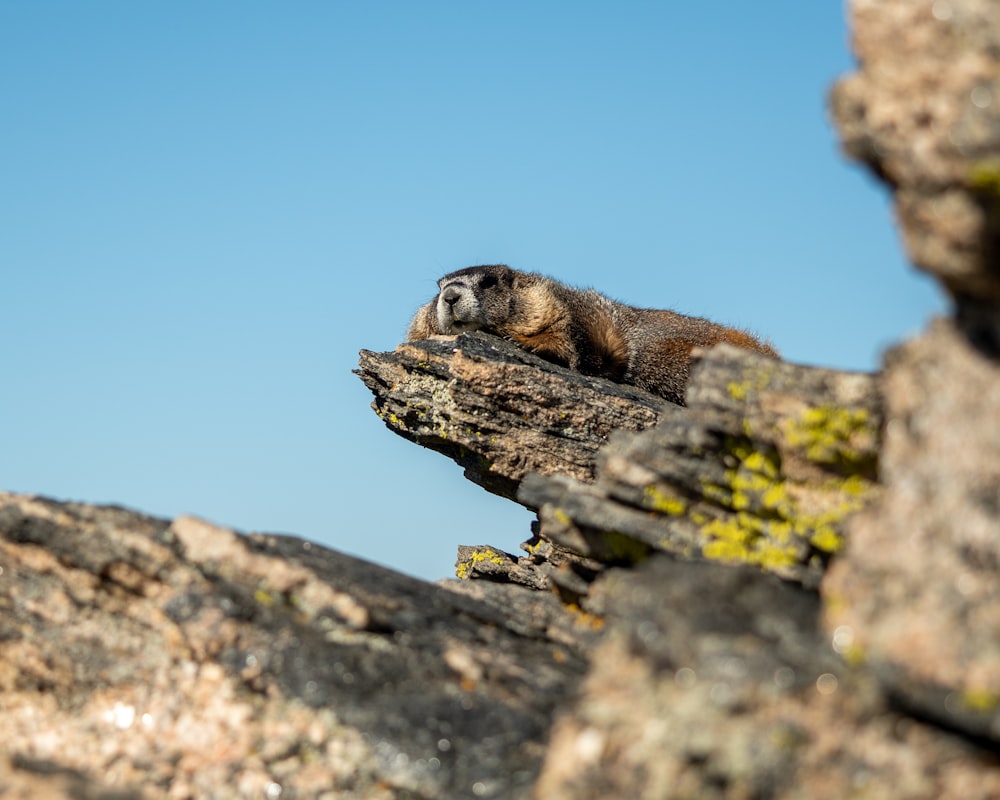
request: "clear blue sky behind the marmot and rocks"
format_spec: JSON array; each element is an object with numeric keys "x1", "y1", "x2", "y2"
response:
[{"x1": 0, "y1": 0, "x2": 945, "y2": 578}]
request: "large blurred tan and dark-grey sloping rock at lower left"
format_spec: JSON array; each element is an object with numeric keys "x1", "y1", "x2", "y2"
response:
[{"x1": 0, "y1": 494, "x2": 584, "y2": 798}]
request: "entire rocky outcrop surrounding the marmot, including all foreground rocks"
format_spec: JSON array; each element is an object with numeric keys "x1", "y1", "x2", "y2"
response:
[{"x1": 0, "y1": 0, "x2": 1000, "y2": 800}]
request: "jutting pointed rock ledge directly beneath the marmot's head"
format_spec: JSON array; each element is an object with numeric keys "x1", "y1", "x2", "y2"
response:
[{"x1": 357, "y1": 333, "x2": 664, "y2": 500}]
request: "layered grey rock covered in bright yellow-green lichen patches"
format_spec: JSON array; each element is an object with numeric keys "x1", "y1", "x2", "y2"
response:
[{"x1": 518, "y1": 346, "x2": 882, "y2": 585}]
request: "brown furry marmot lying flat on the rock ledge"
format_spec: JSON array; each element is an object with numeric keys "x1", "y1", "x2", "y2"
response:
[{"x1": 408, "y1": 264, "x2": 778, "y2": 405}]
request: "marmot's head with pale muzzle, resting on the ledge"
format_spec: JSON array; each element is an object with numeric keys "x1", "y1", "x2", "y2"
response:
[{"x1": 437, "y1": 264, "x2": 518, "y2": 334}]
